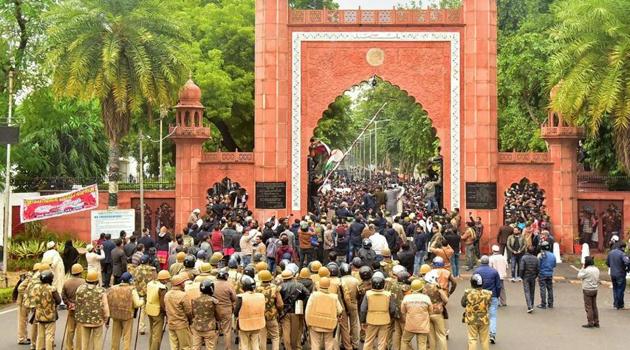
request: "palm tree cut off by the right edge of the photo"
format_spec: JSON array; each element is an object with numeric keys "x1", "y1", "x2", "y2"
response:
[{"x1": 551, "y1": 0, "x2": 630, "y2": 172}]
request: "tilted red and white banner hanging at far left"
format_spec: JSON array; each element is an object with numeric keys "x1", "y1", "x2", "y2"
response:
[{"x1": 20, "y1": 185, "x2": 98, "y2": 222}]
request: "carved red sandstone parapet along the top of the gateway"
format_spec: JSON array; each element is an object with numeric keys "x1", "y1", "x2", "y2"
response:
[{"x1": 289, "y1": 7, "x2": 464, "y2": 25}]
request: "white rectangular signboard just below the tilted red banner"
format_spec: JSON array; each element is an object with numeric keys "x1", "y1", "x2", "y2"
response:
[{"x1": 90, "y1": 209, "x2": 136, "y2": 240}]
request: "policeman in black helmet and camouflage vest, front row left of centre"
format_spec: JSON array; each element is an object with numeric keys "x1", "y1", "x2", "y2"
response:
[{"x1": 191, "y1": 279, "x2": 219, "y2": 350}]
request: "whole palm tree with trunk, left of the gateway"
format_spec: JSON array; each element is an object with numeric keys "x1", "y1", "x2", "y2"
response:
[{"x1": 47, "y1": 0, "x2": 188, "y2": 207}]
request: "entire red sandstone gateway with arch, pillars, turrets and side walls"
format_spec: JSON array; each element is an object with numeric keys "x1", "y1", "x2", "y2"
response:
[{"x1": 38, "y1": 0, "x2": 630, "y2": 252}]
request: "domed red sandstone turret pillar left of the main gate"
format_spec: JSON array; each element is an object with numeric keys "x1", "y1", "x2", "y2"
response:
[{"x1": 169, "y1": 80, "x2": 210, "y2": 232}]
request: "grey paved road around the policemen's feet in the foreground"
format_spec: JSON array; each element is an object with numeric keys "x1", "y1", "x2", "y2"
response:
[{"x1": 0, "y1": 267, "x2": 630, "y2": 350}]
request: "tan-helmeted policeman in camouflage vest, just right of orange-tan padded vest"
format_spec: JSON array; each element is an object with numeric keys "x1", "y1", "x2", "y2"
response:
[{"x1": 256, "y1": 270, "x2": 284, "y2": 350}]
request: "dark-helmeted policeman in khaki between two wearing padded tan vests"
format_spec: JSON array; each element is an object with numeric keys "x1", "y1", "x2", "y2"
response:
[{"x1": 339, "y1": 263, "x2": 361, "y2": 349}]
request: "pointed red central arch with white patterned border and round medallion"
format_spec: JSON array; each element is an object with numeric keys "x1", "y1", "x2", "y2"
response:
[{"x1": 291, "y1": 31, "x2": 461, "y2": 211}]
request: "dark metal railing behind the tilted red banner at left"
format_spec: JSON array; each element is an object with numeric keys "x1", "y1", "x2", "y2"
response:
[{"x1": 12, "y1": 177, "x2": 175, "y2": 193}]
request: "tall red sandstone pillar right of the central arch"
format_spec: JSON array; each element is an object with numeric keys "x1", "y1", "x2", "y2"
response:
[{"x1": 462, "y1": 0, "x2": 502, "y2": 251}]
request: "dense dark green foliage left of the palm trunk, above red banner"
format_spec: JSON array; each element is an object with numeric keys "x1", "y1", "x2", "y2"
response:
[{"x1": 14, "y1": 88, "x2": 107, "y2": 178}]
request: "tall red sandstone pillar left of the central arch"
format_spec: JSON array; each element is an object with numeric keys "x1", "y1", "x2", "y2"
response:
[{"x1": 250, "y1": 0, "x2": 292, "y2": 219}]
